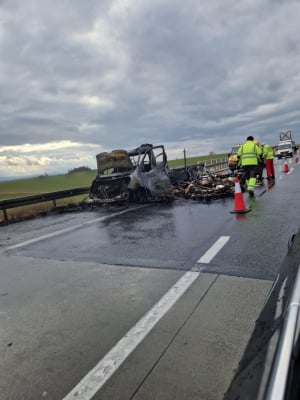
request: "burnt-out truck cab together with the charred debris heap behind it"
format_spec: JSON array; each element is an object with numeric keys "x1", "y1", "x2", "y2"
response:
[{"x1": 90, "y1": 144, "x2": 241, "y2": 204}]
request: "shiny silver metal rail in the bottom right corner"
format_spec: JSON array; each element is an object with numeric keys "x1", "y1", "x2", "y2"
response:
[{"x1": 265, "y1": 266, "x2": 300, "y2": 400}]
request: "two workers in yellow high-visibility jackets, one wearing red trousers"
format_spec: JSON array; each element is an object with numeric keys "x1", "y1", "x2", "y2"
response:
[{"x1": 237, "y1": 136, "x2": 275, "y2": 197}]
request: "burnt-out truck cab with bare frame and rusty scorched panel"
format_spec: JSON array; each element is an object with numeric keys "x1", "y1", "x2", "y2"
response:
[{"x1": 90, "y1": 144, "x2": 174, "y2": 204}]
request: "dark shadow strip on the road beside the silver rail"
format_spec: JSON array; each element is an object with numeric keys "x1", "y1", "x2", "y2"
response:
[{"x1": 224, "y1": 230, "x2": 300, "y2": 400}]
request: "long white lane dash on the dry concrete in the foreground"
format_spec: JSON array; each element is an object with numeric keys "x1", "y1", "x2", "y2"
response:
[{"x1": 63, "y1": 271, "x2": 199, "y2": 400}]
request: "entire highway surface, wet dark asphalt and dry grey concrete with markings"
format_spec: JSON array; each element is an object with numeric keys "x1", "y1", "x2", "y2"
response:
[{"x1": 0, "y1": 159, "x2": 300, "y2": 400}]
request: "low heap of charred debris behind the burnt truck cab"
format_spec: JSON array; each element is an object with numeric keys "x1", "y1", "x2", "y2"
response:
[{"x1": 173, "y1": 174, "x2": 234, "y2": 200}]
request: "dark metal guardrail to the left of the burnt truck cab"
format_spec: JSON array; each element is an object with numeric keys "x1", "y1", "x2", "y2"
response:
[{"x1": 0, "y1": 187, "x2": 90, "y2": 222}]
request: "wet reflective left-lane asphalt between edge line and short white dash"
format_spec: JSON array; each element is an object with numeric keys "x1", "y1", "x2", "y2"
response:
[{"x1": 9, "y1": 199, "x2": 232, "y2": 270}]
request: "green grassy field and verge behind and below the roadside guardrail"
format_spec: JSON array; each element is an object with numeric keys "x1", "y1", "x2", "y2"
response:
[{"x1": 0, "y1": 154, "x2": 227, "y2": 223}]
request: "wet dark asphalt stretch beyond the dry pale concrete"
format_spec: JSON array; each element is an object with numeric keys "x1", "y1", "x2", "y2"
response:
[{"x1": 7, "y1": 156, "x2": 300, "y2": 279}]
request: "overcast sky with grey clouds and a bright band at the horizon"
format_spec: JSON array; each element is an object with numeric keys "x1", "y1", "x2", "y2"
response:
[{"x1": 0, "y1": 0, "x2": 300, "y2": 177}]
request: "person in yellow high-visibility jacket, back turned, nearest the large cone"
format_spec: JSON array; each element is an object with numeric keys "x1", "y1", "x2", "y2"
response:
[{"x1": 237, "y1": 136, "x2": 262, "y2": 197}]
